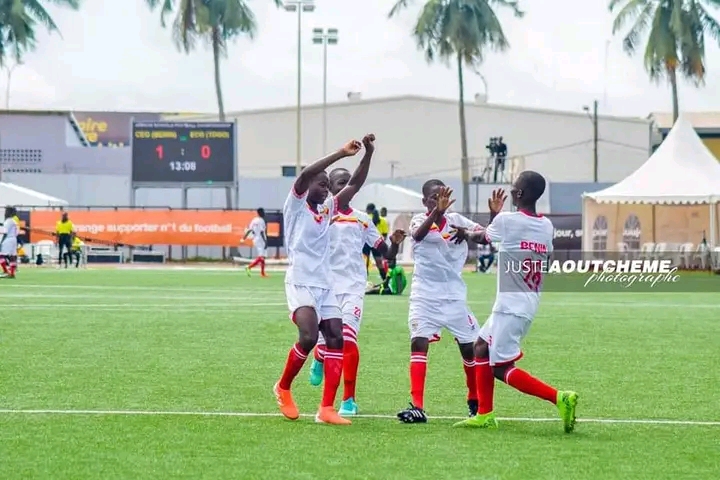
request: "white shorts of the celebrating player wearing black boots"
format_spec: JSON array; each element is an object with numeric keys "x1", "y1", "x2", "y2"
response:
[{"x1": 408, "y1": 298, "x2": 480, "y2": 344}]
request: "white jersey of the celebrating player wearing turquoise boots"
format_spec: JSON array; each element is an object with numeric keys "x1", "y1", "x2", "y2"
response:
[{"x1": 330, "y1": 208, "x2": 384, "y2": 297}]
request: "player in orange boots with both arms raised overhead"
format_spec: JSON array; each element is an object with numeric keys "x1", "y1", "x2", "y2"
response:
[{"x1": 274, "y1": 134, "x2": 375, "y2": 425}]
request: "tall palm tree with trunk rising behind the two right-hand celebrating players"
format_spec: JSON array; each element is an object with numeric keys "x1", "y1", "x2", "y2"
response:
[{"x1": 388, "y1": 0, "x2": 523, "y2": 212}]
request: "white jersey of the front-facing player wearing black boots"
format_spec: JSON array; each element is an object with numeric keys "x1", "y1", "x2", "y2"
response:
[{"x1": 410, "y1": 212, "x2": 482, "y2": 301}]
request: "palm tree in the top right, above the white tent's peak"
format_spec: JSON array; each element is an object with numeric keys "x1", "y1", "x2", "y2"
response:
[{"x1": 609, "y1": 0, "x2": 720, "y2": 120}]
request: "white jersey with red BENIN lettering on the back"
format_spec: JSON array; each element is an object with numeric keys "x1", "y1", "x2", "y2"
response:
[{"x1": 485, "y1": 212, "x2": 554, "y2": 319}]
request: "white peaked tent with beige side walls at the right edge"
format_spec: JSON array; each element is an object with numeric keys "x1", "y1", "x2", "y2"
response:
[{"x1": 583, "y1": 116, "x2": 720, "y2": 250}]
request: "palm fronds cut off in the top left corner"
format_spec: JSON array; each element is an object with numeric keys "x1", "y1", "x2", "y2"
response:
[{"x1": 0, "y1": 0, "x2": 80, "y2": 66}]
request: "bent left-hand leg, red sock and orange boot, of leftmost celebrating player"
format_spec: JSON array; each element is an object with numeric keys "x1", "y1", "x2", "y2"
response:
[{"x1": 273, "y1": 307, "x2": 318, "y2": 420}]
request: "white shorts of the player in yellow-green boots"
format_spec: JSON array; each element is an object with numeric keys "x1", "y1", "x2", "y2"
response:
[{"x1": 480, "y1": 312, "x2": 532, "y2": 366}]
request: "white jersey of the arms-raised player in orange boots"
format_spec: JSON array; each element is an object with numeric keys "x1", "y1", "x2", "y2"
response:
[{"x1": 283, "y1": 187, "x2": 336, "y2": 290}]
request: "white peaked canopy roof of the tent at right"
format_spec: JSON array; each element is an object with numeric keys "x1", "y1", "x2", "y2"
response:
[{"x1": 583, "y1": 116, "x2": 720, "y2": 204}]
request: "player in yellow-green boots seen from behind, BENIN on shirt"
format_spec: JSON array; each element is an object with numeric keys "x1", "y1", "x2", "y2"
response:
[{"x1": 456, "y1": 171, "x2": 578, "y2": 433}]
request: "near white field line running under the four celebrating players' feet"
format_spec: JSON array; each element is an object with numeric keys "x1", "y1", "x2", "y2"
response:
[{"x1": 0, "y1": 409, "x2": 720, "y2": 427}]
